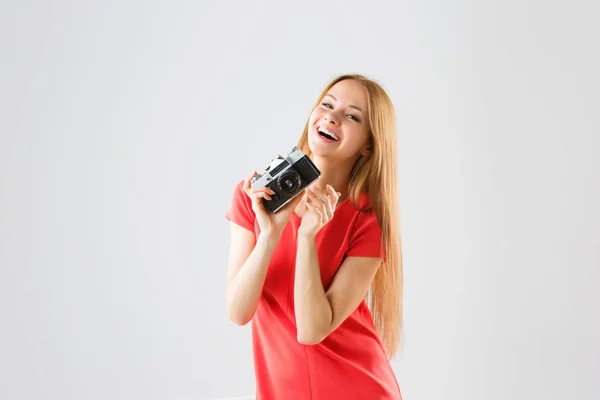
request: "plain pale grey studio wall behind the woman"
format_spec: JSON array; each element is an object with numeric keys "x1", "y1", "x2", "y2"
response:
[{"x1": 0, "y1": 0, "x2": 600, "y2": 400}]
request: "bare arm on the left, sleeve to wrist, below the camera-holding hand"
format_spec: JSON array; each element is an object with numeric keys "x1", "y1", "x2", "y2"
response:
[{"x1": 226, "y1": 222, "x2": 280, "y2": 325}]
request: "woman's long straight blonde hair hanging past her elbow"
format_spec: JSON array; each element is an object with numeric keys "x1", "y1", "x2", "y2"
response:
[{"x1": 298, "y1": 74, "x2": 403, "y2": 358}]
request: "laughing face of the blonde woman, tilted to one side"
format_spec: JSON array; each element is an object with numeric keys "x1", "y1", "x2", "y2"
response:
[{"x1": 308, "y1": 79, "x2": 369, "y2": 160}]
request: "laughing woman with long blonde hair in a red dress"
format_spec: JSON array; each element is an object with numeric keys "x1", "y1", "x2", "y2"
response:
[{"x1": 226, "y1": 75, "x2": 402, "y2": 400}]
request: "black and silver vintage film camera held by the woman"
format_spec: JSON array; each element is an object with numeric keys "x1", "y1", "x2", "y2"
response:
[{"x1": 251, "y1": 146, "x2": 321, "y2": 213}]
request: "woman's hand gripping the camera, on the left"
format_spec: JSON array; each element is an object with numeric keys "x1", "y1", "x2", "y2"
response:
[{"x1": 244, "y1": 171, "x2": 304, "y2": 238}]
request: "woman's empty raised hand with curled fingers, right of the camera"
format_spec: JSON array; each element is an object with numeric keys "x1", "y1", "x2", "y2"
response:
[{"x1": 298, "y1": 185, "x2": 341, "y2": 237}]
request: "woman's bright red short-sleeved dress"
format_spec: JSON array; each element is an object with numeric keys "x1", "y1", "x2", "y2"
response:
[{"x1": 226, "y1": 181, "x2": 402, "y2": 400}]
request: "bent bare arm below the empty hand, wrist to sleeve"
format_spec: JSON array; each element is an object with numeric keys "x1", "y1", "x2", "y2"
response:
[{"x1": 294, "y1": 235, "x2": 382, "y2": 344}]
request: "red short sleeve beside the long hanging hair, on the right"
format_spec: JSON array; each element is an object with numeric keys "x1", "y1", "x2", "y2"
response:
[{"x1": 346, "y1": 211, "x2": 385, "y2": 262}]
